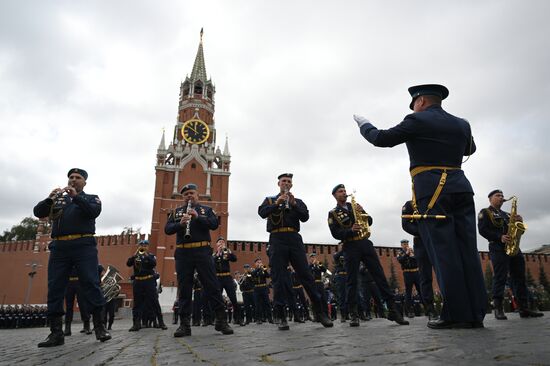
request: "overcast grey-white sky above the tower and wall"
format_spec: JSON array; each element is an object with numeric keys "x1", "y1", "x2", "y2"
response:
[{"x1": 0, "y1": 0, "x2": 550, "y2": 250}]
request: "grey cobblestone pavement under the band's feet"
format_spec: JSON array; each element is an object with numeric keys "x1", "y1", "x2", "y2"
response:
[{"x1": 0, "y1": 312, "x2": 550, "y2": 366}]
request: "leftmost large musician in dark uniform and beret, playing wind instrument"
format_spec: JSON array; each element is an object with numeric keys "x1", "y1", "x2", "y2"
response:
[{"x1": 34, "y1": 168, "x2": 111, "y2": 347}]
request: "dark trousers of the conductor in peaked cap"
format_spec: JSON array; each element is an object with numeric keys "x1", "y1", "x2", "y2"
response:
[{"x1": 417, "y1": 193, "x2": 487, "y2": 322}]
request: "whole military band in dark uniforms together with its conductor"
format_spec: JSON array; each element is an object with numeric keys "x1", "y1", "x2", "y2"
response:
[{"x1": 28, "y1": 84, "x2": 543, "y2": 347}]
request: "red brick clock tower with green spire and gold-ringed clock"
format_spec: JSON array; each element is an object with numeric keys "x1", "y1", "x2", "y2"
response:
[{"x1": 150, "y1": 29, "x2": 231, "y2": 286}]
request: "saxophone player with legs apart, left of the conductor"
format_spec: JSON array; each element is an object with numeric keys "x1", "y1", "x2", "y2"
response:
[{"x1": 328, "y1": 184, "x2": 409, "y2": 327}]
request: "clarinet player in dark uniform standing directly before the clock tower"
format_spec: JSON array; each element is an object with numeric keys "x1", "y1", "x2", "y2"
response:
[{"x1": 164, "y1": 183, "x2": 233, "y2": 337}]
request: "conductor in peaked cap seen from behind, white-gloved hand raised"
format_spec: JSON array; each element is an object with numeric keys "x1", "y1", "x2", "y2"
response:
[{"x1": 354, "y1": 84, "x2": 487, "y2": 329}]
